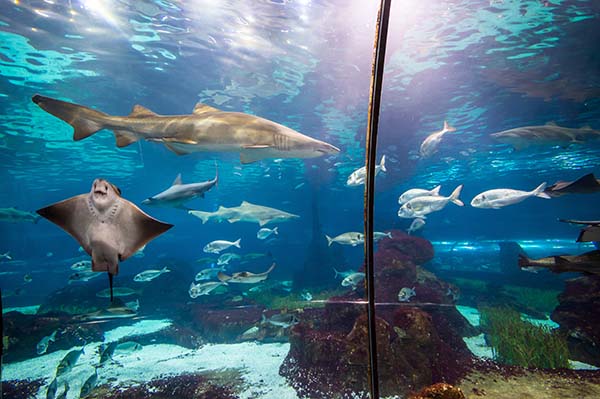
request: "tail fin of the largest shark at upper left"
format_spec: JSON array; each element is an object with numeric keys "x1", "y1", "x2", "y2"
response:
[{"x1": 31, "y1": 94, "x2": 109, "y2": 141}]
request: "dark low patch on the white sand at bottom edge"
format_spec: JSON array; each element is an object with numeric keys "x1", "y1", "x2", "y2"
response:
[{"x1": 87, "y1": 374, "x2": 240, "y2": 399}]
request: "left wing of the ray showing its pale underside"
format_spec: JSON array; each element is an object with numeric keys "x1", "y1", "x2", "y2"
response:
[{"x1": 36, "y1": 194, "x2": 94, "y2": 254}]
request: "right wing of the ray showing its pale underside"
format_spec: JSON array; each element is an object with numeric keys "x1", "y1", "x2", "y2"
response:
[{"x1": 115, "y1": 198, "x2": 173, "y2": 260}]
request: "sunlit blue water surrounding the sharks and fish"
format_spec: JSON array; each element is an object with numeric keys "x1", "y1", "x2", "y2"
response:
[{"x1": 0, "y1": 0, "x2": 600, "y2": 398}]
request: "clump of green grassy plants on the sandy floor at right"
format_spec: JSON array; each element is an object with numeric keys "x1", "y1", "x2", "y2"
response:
[{"x1": 480, "y1": 307, "x2": 569, "y2": 368}]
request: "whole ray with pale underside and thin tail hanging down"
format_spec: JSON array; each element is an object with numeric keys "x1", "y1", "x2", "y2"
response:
[{"x1": 37, "y1": 179, "x2": 173, "y2": 301}]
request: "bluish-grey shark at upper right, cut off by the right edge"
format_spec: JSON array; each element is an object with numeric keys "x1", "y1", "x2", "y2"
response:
[{"x1": 490, "y1": 122, "x2": 600, "y2": 151}]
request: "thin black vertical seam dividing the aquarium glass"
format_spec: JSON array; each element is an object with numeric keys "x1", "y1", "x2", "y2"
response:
[{"x1": 365, "y1": 0, "x2": 392, "y2": 399}]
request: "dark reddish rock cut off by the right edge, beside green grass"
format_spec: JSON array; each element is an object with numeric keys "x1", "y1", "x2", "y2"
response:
[{"x1": 551, "y1": 275, "x2": 600, "y2": 367}]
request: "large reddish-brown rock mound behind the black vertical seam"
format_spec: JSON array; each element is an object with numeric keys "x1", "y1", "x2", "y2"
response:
[{"x1": 280, "y1": 231, "x2": 476, "y2": 398}]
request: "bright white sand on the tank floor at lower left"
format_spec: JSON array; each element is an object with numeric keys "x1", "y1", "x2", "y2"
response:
[{"x1": 3, "y1": 320, "x2": 297, "y2": 399}]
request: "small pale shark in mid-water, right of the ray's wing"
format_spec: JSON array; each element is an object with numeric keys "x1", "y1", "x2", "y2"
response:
[{"x1": 188, "y1": 201, "x2": 300, "y2": 227}]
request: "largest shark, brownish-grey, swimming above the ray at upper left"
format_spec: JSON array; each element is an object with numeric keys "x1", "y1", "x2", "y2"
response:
[{"x1": 32, "y1": 94, "x2": 340, "y2": 164}]
